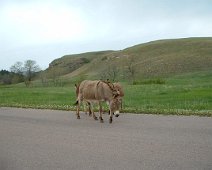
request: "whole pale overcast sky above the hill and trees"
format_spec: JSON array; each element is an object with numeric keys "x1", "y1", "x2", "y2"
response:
[{"x1": 0, "y1": 0, "x2": 212, "y2": 70}]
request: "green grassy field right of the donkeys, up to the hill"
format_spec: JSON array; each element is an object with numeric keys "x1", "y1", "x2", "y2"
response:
[{"x1": 125, "y1": 72, "x2": 212, "y2": 116}]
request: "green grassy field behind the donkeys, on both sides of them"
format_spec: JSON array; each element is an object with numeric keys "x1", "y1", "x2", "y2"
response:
[{"x1": 0, "y1": 71, "x2": 212, "y2": 116}]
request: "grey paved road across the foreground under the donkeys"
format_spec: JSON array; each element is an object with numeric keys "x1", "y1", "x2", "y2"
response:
[{"x1": 0, "y1": 108, "x2": 212, "y2": 170}]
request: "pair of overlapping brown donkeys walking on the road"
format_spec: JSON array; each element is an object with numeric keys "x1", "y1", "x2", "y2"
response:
[{"x1": 75, "y1": 80, "x2": 124, "y2": 123}]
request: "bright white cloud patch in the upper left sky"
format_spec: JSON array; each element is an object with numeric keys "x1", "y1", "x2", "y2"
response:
[{"x1": 0, "y1": 3, "x2": 85, "y2": 45}]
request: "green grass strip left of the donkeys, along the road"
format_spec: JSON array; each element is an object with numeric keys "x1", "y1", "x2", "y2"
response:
[{"x1": 0, "y1": 86, "x2": 76, "y2": 110}]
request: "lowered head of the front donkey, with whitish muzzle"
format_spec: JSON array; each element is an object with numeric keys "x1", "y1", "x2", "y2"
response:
[{"x1": 110, "y1": 96, "x2": 122, "y2": 117}]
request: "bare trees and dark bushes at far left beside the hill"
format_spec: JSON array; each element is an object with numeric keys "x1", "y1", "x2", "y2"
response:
[{"x1": 0, "y1": 60, "x2": 64, "y2": 87}]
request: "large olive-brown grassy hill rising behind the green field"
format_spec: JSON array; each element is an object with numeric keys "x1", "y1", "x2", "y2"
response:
[{"x1": 47, "y1": 38, "x2": 212, "y2": 79}]
